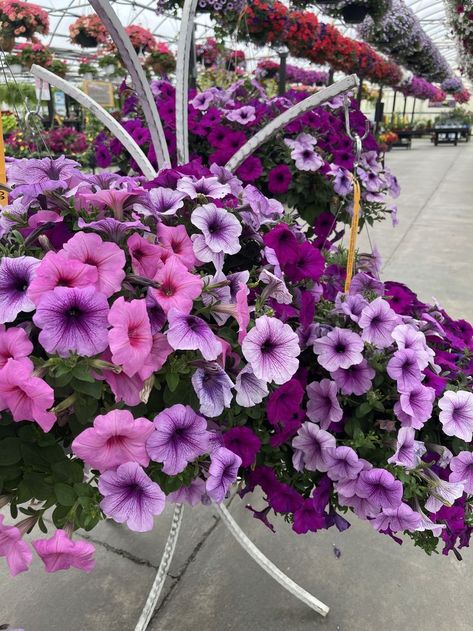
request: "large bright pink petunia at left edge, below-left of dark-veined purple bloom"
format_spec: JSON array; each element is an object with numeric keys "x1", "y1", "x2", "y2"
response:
[{"x1": 0, "y1": 359, "x2": 56, "y2": 432}]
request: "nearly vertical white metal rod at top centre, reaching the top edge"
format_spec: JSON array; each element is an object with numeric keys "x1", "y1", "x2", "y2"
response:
[{"x1": 176, "y1": 0, "x2": 197, "y2": 164}]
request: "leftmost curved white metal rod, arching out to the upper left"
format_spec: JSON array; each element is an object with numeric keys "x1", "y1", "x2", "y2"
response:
[{"x1": 31, "y1": 64, "x2": 156, "y2": 180}]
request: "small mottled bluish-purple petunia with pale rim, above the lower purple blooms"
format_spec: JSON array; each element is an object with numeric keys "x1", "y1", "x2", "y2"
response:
[{"x1": 192, "y1": 362, "x2": 233, "y2": 418}]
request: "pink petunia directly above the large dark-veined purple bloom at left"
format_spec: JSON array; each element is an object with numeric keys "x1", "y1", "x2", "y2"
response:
[{"x1": 27, "y1": 252, "x2": 98, "y2": 305}]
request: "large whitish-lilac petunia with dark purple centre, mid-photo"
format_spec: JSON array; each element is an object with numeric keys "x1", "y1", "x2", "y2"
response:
[{"x1": 242, "y1": 316, "x2": 300, "y2": 385}]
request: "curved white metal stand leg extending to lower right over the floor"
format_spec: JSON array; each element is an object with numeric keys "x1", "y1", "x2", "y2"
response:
[{"x1": 214, "y1": 504, "x2": 330, "y2": 618}]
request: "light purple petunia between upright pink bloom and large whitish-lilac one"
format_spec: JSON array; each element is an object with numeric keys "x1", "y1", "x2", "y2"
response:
[{"x1": 167, "y1": 309, "x2": 222, "y2": 361}]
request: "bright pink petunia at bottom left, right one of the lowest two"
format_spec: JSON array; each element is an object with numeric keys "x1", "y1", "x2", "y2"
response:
[{"x1": 32, "y1": 530, "x2": 95, "y2": 572}]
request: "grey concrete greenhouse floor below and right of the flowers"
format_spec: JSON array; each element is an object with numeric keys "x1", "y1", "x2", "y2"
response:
[{"x1": 0, "y1": 141, "x2": 473, "y2": 631}]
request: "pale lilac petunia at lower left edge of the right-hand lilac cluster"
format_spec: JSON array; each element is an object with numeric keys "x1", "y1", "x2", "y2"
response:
[{"x1": 292, "y1": 423, "x2": 336, "y2": 471}]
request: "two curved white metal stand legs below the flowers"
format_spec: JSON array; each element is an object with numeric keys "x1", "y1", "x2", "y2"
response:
[{"x1": 135, "y1": 504, "x2": 330, "y2": 631}]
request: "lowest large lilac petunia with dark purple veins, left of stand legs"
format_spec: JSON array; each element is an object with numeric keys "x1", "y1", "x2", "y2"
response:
[{"x1": 99, "y1": 462, "x2": 166, "y2": 532}]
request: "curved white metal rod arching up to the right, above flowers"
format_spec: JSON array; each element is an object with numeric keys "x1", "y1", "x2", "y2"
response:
[{"x1": 225, "y1": 75, "x2": 359, "y2": 171}]
